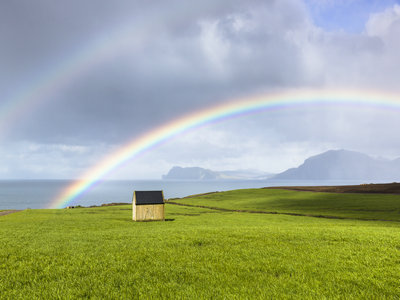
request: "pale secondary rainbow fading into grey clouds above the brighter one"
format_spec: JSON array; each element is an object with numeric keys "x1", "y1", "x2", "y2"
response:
[{"x1": 0, "y1": 4, "x2": 217, "y2": 135}]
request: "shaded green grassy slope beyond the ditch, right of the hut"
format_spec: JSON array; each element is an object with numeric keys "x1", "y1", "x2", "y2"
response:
[{"x1": 176, "y1": 189, "x2": 400, "y2": 221}]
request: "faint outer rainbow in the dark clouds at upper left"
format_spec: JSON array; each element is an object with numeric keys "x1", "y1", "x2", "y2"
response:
[{"x1": 0, "y1": 22, "x2": 150, "y2": 134}]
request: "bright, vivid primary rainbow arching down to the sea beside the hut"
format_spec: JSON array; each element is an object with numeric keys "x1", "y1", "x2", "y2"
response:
[{"x1": 48, "y1": 90, "x2": 400, "y2": 208}]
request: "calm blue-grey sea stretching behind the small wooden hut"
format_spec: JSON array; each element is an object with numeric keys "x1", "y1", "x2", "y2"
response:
[{"x1": 0, "y1": 180, "x2": 372, "y2": 210}]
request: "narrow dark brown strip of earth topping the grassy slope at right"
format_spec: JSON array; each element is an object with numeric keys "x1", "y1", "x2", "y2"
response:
[{"x1": 266, "y1": 182, "x2": 400, "y2": 194}]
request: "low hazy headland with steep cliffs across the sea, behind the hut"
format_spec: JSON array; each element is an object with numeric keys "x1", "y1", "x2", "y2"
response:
[{"x1": 162, "y1": 166, "x2": 273, "y2": 180}]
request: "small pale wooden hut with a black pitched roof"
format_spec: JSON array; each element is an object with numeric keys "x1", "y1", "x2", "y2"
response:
[{"x1": 132, "y1": 191, "x2": 165, "y2": 221}]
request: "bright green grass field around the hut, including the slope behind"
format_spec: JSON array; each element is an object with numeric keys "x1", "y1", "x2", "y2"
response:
[{"x1": 0, "y1": 190, "x2": 400, "y2": 299}]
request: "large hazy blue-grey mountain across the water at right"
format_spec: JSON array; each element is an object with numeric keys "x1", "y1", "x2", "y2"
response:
[{"x1": 272, "y1": 150, "x2": 400, "y2": 181}]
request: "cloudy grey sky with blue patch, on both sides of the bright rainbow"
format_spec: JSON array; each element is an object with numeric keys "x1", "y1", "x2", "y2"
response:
[{"x1": 0, "y1": 0, "x2": 400, "y2": 179}]
